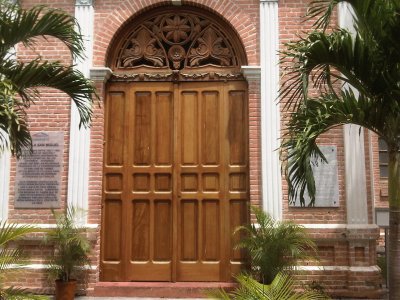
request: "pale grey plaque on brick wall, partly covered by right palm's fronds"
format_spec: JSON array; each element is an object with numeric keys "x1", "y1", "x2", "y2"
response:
[{"x1": 292, "y1": 146, "x2": 339, "y2": 207}]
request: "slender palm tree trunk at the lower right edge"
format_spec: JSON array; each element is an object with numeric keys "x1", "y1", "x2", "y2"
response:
[{"x1": 388, "y1": 149, "x2": 400, "y2": 300}]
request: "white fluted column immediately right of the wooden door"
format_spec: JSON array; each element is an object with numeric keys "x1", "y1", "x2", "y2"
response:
[{"x1": 260, "y1": 0, "x2": 282, "y2": 220}]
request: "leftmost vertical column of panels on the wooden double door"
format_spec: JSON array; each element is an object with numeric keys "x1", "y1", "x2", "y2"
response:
[{"x1": 101, "y1": 85, "x2": 127, "y2": 281}]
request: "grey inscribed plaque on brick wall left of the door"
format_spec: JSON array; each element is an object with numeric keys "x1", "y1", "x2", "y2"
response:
[{"x1": 15, "y1": 131, "x2": 64, "y2": 208}]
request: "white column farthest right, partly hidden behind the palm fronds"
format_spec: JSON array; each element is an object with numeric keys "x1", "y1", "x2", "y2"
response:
[{"x1": 339, "y1": 3, "x2": 368, "y2": 224}]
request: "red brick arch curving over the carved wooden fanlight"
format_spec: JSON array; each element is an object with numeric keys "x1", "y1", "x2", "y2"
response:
[{"x1": 93, "y1": 0, "x2": 258, "y2": 66}]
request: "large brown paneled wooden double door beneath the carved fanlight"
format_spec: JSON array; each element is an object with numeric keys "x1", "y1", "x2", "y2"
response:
[{"x1": 101, "y1": 81, "x2": 249, "y2": 282}]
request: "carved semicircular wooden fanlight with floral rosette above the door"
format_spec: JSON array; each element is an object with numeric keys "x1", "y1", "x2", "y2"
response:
[{"x1": 113, "y1": 12, "x2": 244, "y2": 79}]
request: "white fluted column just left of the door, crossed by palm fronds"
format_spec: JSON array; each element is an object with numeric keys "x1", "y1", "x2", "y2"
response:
[{"x1": 67, "y1": 0, "x2": 94, "y2": 223}]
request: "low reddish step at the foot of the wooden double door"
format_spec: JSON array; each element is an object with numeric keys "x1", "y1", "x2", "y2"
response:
[{"x1": 88, "y1": 282, "x2": 236, "y2": 298}]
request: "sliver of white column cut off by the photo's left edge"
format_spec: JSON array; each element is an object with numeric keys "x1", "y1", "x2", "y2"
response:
[{"x1": 0, "y1": 150, "x2": 11, "y2": 221}]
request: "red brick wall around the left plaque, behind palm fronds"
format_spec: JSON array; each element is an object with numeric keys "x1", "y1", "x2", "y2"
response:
[{"x1": 9, "y1": 0, "x2": 74, "y2": 224}]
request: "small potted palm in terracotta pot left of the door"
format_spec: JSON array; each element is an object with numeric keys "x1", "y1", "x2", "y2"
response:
[{"x1": 45, "y1": 207, "x2": 91, "y2": 300}]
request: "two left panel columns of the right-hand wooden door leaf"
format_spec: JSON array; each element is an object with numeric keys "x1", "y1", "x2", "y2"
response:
[{"x1": 176, "y1": 83, "x2": 228, "y2": 281}]
